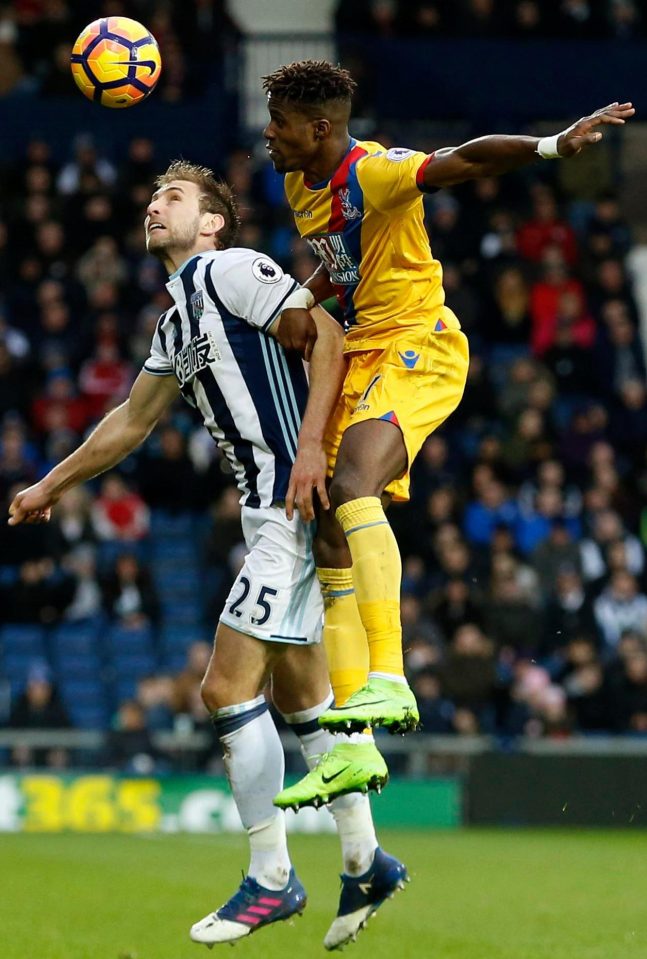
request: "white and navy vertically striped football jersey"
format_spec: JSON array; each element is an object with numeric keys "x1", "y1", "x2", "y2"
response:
[{"x1": 144, "y1": 249, "x2": 308, "y2": 507}]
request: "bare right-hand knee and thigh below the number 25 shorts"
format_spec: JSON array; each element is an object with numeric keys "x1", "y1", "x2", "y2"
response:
[{"x1": 272, "y1": 644, "x2": 330, "y2": 713}]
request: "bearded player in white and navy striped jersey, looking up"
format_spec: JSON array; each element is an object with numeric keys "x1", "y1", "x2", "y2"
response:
[{"x1": 9, "y1": 161, "x2": 386, "y2": 945}]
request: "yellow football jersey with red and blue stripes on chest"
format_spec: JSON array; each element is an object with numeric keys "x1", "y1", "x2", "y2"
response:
[{"x1": 285, "y1": 139, "x2": 459, "y2": 351}]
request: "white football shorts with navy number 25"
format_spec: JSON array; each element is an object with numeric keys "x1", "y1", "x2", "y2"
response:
[{"x1": 220, "y1": 506, "x2": 323, "y2": 645}]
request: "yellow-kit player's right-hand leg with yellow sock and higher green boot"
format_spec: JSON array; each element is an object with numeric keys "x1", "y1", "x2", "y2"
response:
[{"x1": 321, "y1": 419, "x2": 419, "y2": 732}]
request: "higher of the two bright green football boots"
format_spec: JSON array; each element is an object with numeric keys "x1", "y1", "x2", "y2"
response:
[{"x1": 319, "y1": 679, "x2": 420, "y2": 735}]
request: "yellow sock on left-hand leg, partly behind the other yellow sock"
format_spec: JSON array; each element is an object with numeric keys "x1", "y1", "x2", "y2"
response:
[{"x1": 317, "y1": 568, "x2": 368, "y2": 706}]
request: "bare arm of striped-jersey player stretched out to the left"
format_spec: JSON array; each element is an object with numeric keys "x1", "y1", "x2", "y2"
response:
[{"x1": 9, "y1": 371, "x2": 179, "y2": 526}]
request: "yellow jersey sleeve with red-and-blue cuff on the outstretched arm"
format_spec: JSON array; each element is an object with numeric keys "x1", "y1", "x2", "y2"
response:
[{"x1": 357, "y1": 147, "x2": 433, "y2": 210}]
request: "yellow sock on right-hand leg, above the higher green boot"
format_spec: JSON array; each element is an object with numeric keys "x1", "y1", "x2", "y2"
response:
[{"x1": 335, "y1": 496, "x2": 404, "y2": 676}]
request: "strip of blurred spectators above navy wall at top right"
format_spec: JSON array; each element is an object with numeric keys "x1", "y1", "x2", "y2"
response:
[{"x1": 335, "y1": 0, "x2": 647, "y2": 40}]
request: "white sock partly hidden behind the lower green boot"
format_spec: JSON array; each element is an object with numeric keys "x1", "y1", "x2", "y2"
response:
[{"x1": 282, "y1": 691, "x2": 377, "y2": 876}]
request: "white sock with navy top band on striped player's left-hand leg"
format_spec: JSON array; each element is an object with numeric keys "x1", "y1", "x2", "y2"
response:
[{"x1": 212, "y1": 696, "x2": 291, "y2": 889}]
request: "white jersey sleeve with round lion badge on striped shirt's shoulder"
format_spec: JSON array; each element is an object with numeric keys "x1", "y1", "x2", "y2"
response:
[{"x1": 205, "y1": 250, "x2": 299, "y2": 332}]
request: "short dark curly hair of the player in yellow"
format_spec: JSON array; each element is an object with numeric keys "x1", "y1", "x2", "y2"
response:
[{"x1": 263, "y1": 60, "x2": 357, "y2": 106}]
